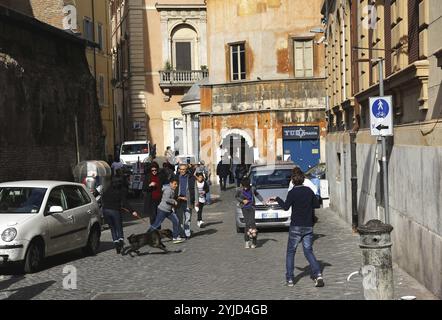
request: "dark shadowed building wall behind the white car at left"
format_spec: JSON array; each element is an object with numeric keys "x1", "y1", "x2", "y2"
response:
[{"x1": 0, "y1": 1, "x2": 103, "y2": 181}]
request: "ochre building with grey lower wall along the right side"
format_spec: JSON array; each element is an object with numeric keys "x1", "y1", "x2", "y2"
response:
[{"x1": 322, "y1": 0, "x2": 442, "y2": 296}]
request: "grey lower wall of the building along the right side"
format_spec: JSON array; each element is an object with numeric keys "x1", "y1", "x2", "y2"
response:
[{"x1": 326, "y1": 125, "x2": 442, "y2": 297}]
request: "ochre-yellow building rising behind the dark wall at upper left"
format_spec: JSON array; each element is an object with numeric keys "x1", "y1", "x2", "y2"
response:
[{"x1": 16, "y1": 0, "x2": 117, "y2": 159}]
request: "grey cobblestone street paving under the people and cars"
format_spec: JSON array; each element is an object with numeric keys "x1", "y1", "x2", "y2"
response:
[{"x1": 0, "y1": 185, "x2": 437, "y2": 300}]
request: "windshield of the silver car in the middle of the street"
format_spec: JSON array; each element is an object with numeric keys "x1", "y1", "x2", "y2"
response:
[{"x1": 250, "y1": 169, "x2": 292, "y2": 189}]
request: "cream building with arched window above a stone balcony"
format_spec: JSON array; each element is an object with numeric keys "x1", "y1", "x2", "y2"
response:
[{"x1": 111, "y1": 0, "x2": 208, "y2": 153}]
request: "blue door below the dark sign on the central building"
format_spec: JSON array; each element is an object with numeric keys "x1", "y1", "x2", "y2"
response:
[{"x1": 284, "y1": 140, "x2": 321, "y2": 172}]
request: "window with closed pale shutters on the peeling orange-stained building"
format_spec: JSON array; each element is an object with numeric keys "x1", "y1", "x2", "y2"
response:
[{"x1": 293, "y1": 39, "x2": 313, "y2": 78}]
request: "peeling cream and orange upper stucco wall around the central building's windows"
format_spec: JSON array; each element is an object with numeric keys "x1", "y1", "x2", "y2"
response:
[{"x1": 207, "y1": 0, "x2": 325, "y2": 83}]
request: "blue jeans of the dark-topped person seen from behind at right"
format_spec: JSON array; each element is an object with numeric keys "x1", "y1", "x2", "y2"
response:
[{"x1": 286, "y1": 226, "x2": 321, "y2": 281}]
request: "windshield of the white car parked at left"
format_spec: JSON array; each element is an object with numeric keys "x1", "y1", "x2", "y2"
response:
[{"x1": 0, "y1": 187, "x2": 47, "y2": 214}]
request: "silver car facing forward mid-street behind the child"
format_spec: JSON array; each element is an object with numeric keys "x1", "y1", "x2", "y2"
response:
[{"x1": 235, "y1": 162, "x2": 296, "y2": 233}]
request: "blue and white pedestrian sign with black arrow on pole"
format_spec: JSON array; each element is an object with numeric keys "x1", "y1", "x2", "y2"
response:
[{"x1": 370, "y1": 96, "x2": 393, "y2": 137}]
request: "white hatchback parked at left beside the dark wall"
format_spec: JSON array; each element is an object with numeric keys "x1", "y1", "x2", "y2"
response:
[{"x1": 0, "y1": 181, "x2": 101, "y2": 273}]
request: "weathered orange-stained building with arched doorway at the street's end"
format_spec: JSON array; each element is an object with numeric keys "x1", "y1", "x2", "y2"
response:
[{"x1": 199, "y1": 0, "x2": 326, "y2": 170}]
